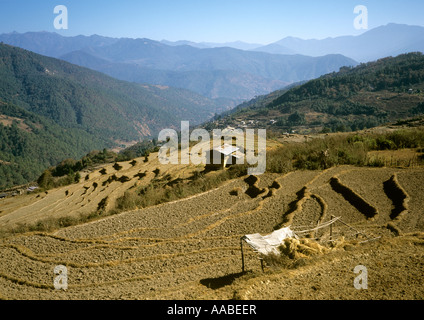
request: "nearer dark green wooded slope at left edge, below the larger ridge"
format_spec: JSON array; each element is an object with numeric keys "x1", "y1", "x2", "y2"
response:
[{"x1": 0, "y1": 102, "x2": 105, "y2": 189}]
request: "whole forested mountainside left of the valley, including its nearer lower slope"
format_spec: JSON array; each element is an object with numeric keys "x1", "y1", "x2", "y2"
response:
[{"x1": 0, "y1": 44, "x2": 222, "y2": 189}]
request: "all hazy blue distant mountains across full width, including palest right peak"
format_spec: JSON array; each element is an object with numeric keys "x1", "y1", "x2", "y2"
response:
[{"x1": 0, "y1": 24, "x2": 424, "y2": 101}]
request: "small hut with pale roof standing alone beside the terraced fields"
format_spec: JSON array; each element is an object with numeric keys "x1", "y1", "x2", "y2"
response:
[{"x1": 206, "y1": 144, "x2": 244, "y2": 170}]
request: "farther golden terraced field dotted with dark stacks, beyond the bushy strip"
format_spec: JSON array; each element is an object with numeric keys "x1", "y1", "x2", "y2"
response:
[{"x1": 0, "y1": 154, "x2": 195, "y2": 226}]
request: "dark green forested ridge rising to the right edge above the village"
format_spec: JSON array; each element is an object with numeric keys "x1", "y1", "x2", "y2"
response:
[{"x1": 208, "y1": 52, "x2": 424, "y2": 131}]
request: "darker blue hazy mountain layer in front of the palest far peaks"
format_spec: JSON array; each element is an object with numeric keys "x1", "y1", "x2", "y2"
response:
[{"x1": 0, "y1": 32, "x2": 357, "y2": 101}]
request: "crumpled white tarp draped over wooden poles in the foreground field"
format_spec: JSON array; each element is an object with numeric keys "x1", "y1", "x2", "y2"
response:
[{"x1": 242, "y1": 227, "x2": 297, "y2": 255}]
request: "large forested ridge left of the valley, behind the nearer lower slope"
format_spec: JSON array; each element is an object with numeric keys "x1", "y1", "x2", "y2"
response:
[{"x1": 0, "y1": 45, "x2": 225, "y2": 141}]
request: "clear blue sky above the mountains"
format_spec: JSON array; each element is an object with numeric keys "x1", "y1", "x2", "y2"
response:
[{"x1": 0, "y1": 0, "x2": 424, "y2": 44}]
